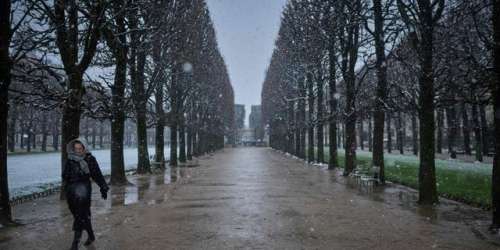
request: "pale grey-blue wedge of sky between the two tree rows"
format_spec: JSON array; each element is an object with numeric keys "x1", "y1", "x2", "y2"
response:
[{"x1": 207, "y1": 0, "x2": 287, "y2": 125}]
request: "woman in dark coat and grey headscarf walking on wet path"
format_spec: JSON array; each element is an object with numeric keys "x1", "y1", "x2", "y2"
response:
[{"x1": 62, "y1": 139, "x2": 109, "y2": 249}]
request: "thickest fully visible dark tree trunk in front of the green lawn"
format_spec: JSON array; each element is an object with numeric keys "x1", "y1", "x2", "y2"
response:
[{"x1": 398, "y1": 0, "x2": 445, "y2": 204}]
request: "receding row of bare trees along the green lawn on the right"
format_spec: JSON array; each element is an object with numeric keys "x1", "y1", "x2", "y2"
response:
[{"x1": 262, "y1": 0, "x2": 500, "y2": 229}]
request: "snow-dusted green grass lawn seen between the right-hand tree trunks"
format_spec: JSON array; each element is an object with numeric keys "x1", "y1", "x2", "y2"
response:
[{"x1": 325, "y1": 148, "x2": 491, "y2": 208}]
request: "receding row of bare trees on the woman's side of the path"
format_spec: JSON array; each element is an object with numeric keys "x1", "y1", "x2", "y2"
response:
[{"x1": 0, "y1": 0, "x2": 234, "y2": 222}]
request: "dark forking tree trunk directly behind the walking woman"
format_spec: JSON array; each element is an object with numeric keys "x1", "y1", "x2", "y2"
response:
[{"x1": 54, "y1": 0, "x2": 104, "y2": 199}]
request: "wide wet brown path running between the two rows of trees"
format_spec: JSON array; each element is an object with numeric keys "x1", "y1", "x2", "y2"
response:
[{"x1": 0, "y1": 148, "x2": 500, "y2": 249}]
